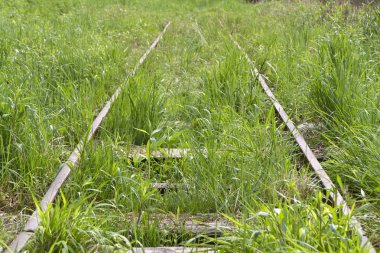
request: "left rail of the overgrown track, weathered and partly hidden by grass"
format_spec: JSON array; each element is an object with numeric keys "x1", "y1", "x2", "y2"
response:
[{"x1": 6, "y1": 22, "x2": 170, "y2": 253}]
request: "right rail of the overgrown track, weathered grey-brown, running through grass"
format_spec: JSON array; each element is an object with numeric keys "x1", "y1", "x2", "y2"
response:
[{"x1": 229, "y1": 34, "x2": 376, "y2": 253}]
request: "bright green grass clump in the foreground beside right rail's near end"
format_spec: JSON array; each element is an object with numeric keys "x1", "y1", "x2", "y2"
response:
[{"x1": 211, "y1": 196, "x2": 366, "y2": 252}]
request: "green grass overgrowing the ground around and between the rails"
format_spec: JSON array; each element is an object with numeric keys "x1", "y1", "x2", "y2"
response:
[{"x1": 0, "y1": 0, "x2": 380, "y2": 252}]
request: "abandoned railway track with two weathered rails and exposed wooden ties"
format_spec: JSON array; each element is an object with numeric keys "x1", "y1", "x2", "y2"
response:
[{"x1": 2, "y1": 22, "x2": 376, "y2": 253}]
